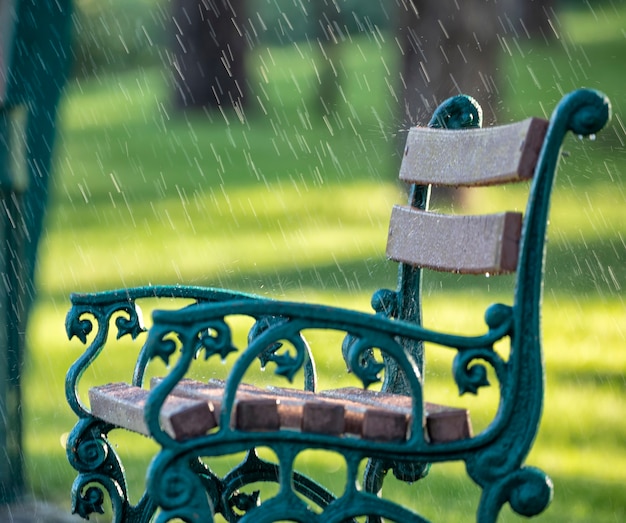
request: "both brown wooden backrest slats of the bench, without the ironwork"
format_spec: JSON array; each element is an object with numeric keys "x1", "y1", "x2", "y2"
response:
[{"x1": 387, "y1": 118, "x2": 548, "y2": 274}]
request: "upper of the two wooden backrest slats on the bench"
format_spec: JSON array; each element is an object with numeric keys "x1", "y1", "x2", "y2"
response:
[{"x1": 400, "y1": 118, "x2": 548, "y2": 186}]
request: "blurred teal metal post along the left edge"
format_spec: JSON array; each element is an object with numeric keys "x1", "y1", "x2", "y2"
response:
[{"x1": 0, "y1": 0, "x2": 71, "y2": 503}]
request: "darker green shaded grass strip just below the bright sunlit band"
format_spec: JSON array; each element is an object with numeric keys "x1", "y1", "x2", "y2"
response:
[{"x1": 40, "y1": 229, "x2": 626, "y2": 310}]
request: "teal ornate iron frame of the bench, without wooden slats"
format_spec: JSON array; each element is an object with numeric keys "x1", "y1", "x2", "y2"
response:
[{"x1": 66, "y1": 89, "x2": 610, "y2": 523}]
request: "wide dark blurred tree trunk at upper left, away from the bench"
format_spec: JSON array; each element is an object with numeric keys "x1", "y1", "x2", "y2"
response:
[{"x1": 171, "y1": 0, "x2": 247, "y2": 110}]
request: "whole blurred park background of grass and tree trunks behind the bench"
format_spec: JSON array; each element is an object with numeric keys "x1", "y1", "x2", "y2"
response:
[{"x1": 13, "y1": 0, "x2": 626, "y2": 522}]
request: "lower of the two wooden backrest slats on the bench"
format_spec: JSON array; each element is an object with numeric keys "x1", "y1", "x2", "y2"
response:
[{"x1": 387, "y1": 205, "x2": 522, "y2": 274}]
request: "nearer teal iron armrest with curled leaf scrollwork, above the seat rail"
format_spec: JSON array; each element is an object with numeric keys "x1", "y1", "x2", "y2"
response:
[{"x1": 144, "y1": 298, "x2": 512, "y2": 447}]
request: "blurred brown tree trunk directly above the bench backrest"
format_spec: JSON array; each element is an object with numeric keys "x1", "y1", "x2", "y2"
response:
[{"x1": 396, "y1": 0, "x2": 500, "y2": 127}]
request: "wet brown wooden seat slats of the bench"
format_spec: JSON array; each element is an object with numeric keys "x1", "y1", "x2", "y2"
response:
[{"x1": 89, "y1": 378, "x2": 471, "y2": 443}]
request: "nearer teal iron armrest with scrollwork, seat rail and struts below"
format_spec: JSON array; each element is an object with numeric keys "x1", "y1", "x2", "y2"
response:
[{"x1": 140, "y1": 300, "x2": 511, "y2": 521}]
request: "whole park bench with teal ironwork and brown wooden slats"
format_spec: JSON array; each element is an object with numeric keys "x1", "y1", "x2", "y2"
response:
[{"x1": 66, "y1": 89, "x2": 610, "y2": 523}]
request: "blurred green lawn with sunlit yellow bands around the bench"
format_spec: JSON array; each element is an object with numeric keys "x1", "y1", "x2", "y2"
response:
[{"x1": 25, "y1": 4, "x2": 626, "y2": 522}]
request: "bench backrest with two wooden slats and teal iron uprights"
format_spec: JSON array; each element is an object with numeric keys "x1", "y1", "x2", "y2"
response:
[{"x1": 372, "y1": 90, "x2": 609, "y2": 393}]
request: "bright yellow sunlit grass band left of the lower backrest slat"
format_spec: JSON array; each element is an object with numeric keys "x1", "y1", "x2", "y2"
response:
[{"x1": 43, "y1": 183, "x2": 399, "y2": 293}]
